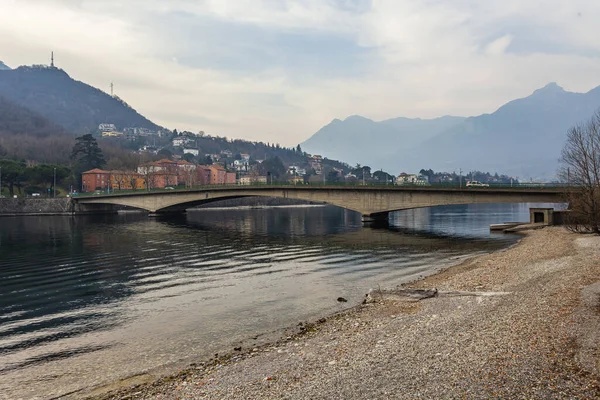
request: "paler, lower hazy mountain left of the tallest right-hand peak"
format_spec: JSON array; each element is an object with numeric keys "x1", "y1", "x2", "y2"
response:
[{"x1": 301, "y1": 115, "x2": 464, "y2": 165}]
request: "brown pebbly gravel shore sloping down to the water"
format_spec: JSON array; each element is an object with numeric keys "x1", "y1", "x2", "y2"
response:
[{"x1": 88, "y1": 227, "x2": 600, "y2": 400}]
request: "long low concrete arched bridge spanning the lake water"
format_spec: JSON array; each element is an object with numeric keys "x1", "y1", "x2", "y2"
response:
[{"x1": 73, "y1": 185, "x2": 565, "y2": 221}]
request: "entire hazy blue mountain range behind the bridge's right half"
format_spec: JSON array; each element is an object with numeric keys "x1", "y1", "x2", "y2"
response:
[{"x1": 301, "y1": 83, "x2": 600, "y2": 179}]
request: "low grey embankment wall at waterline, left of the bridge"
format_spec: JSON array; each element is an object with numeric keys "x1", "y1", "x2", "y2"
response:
[{"x1": 0, "y1": 197, "x2": 74, "y2": 217}]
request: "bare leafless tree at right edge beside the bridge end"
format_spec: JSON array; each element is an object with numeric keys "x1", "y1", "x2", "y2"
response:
[{"x1": 560, "y1": 111, "x2": 600, "y2": 234}]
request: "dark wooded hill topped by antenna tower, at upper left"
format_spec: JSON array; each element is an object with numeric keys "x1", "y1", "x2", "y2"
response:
[{"x1": 0, "y1": 66, "x2": 161, "y2": 135}]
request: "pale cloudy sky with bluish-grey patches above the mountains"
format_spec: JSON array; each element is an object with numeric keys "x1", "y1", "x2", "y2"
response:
[{"x1": 0, "y1": 0, "x2": 600, "y2": 146}]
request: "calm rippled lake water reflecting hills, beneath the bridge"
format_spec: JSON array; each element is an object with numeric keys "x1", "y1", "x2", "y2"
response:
[{"x1": 0, "y1": 205, "x2": 556, "y2": 399}]
